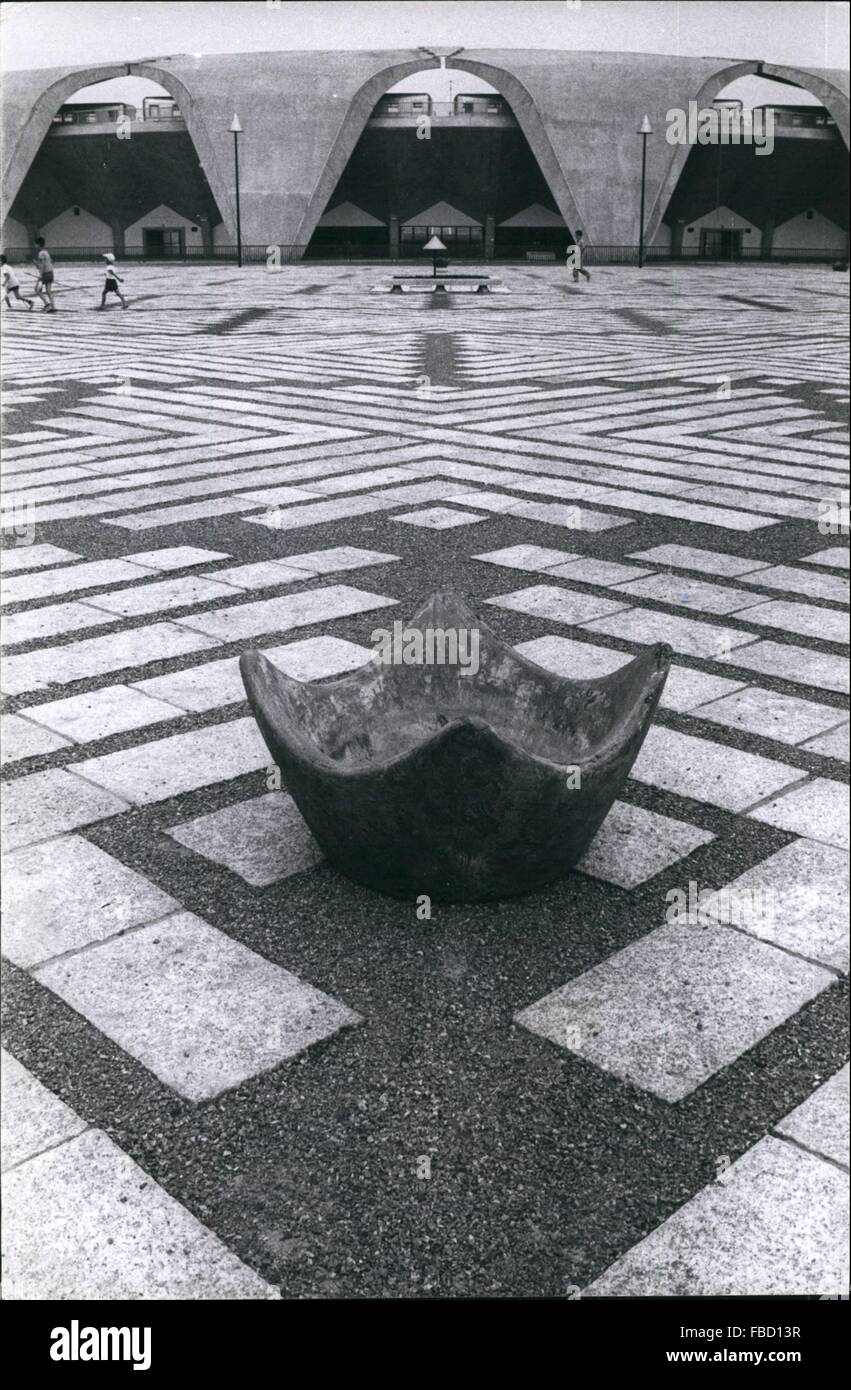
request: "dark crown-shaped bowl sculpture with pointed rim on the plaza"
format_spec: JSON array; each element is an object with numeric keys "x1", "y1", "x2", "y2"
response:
[{"x1": 239, "y1": 594, "x2": 672, "y2": 902}]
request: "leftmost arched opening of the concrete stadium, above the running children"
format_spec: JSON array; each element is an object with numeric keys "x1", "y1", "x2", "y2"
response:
[{"x1": 3, "y1": 71, "x2": 227, "y2": 260}]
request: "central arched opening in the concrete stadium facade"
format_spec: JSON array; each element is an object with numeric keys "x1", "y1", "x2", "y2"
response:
[{"x1": 306, "y1": 67, "x2": 573, "y2": 260}]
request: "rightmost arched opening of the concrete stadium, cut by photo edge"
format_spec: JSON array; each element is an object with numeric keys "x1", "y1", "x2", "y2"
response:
[{"x1": 654, "y1": 72, "x2": 848, "y2": 261}]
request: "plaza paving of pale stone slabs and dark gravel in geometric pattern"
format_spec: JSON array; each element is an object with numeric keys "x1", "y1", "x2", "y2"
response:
[{"x1": 1, "y1": 265, "x2": 848, "y2": 1300}]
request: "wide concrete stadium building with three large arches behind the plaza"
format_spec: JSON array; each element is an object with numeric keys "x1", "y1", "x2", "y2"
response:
[{"x1": 3, "y1": 49, "x2": 848, "y2": 259}]
